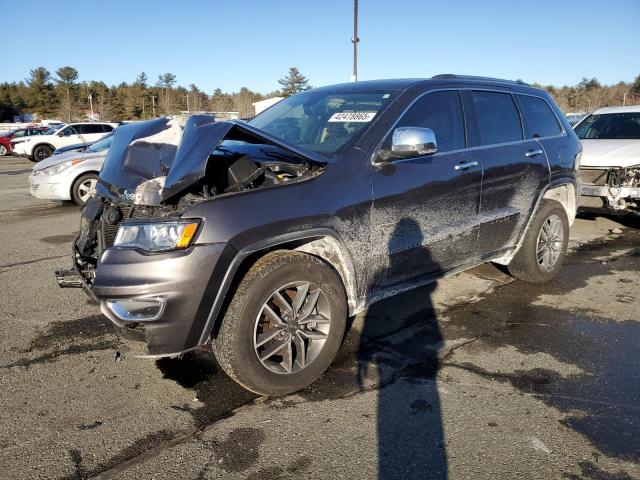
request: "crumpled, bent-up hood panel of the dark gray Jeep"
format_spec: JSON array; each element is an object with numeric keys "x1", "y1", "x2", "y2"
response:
[{"x1": 98, "y1": 115, "x2": 326, "y2": 202}]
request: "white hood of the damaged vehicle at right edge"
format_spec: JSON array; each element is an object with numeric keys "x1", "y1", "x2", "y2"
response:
[{"x1": 581, "y1": 140, "x2": 640, "y2": 168}]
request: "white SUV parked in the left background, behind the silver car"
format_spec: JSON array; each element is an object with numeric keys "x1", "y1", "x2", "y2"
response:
[{"x1": 13, "y1": 122, "x2": 118, "y2": 162}]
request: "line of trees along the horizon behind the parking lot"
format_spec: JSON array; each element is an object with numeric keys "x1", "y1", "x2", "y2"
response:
[{"x1": 0, "y1": 66, "x2": 640, "y2": 122}]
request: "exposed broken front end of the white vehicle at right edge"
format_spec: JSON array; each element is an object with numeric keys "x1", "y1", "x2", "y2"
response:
[{"x1": 580, "y1": 167, "x2": 640, "y2": 210}]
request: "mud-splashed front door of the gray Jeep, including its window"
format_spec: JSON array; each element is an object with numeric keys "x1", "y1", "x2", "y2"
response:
[{"x1": 371, "y1": 90, "x2": 482, "y2": 291}]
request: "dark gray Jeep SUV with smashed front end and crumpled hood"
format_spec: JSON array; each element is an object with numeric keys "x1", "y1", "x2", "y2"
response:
[{"x1": 57, "y1": 75, "x2": 581, "y2": 395}]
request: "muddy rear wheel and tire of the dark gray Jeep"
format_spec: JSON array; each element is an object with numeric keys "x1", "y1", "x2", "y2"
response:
[{"x1": 507, "y1": 199, "x2": 569, "y2": 283}]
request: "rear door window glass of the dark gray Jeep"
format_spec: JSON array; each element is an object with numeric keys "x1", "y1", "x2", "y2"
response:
[{"x1": 472, "y1": 91, "x2": 522, "y2": 145}]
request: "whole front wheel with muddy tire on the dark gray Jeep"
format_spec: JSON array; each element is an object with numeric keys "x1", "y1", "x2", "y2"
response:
[{"x1": 212, "y1": 250, "x2": 347, "y2": 396}]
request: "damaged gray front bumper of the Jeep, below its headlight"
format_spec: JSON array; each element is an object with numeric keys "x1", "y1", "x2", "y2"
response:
[{"x1": 56, "y1": 244, "x2": 225, "y2": 358}]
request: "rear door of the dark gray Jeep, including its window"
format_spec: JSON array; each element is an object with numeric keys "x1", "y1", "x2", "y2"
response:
[{"x1": 465, "y1": 89, "x2": 549, "y2": 256}]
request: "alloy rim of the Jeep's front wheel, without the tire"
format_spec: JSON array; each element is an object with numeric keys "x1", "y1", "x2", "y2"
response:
[{"x1": 253, "y1": 282, "x2": 331, "y2": 374}]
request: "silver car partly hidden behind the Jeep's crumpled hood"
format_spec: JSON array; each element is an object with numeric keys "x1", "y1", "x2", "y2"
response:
[{"x1": 29, "y1": 134, "x2": 113, "y2": 205}]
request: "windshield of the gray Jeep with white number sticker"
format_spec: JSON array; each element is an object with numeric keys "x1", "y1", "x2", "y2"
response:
[{"x1": 249, "y1": 91, "x2": 392, "y2": 156}]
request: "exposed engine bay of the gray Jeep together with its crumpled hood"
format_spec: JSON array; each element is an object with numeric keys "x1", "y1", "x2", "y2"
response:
[{"x1": 56, "y1": 116, "x2": 326, "y2": 294}]
